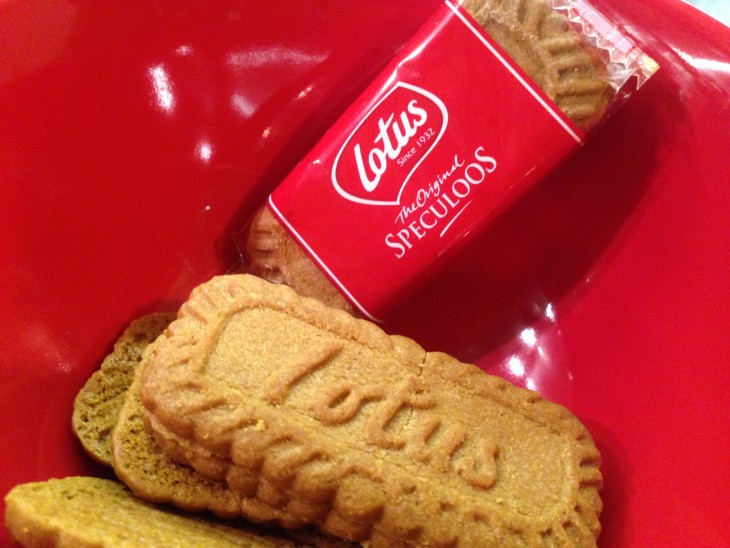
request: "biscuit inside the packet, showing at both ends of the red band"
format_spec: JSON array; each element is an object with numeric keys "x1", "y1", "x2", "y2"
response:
[{"x1": 246, "y1": 0, "x2": 614, "y2": 314}]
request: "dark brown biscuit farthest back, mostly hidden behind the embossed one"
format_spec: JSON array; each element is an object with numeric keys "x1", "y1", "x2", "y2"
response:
[{"x1": 71, "y1": 313, "x2": 175, "y2": 466}]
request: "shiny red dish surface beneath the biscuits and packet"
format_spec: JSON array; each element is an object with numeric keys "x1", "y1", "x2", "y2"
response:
[{"x1": 0, "y1": 0, "x2": 730, "y2": 546}]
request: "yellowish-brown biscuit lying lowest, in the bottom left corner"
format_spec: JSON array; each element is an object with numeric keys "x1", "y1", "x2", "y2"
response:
[{"x1": 5, "y1": 477, "x2": 295, "y2": 548}]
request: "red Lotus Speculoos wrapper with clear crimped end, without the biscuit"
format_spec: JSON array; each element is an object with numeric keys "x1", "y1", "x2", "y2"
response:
[{"x1": 243, "y1": 0, "x2": 656, "y2": 321}]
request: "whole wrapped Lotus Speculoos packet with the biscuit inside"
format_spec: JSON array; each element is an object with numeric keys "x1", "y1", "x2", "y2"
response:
[{"x1": 239, "y1": 0, "x2": 658, "y2": 321}]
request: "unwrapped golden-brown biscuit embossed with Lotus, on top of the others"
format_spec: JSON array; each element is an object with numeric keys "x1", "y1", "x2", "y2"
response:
[{"x1": 142, "y1": 275, "x2": 602, "y2": 546}]
